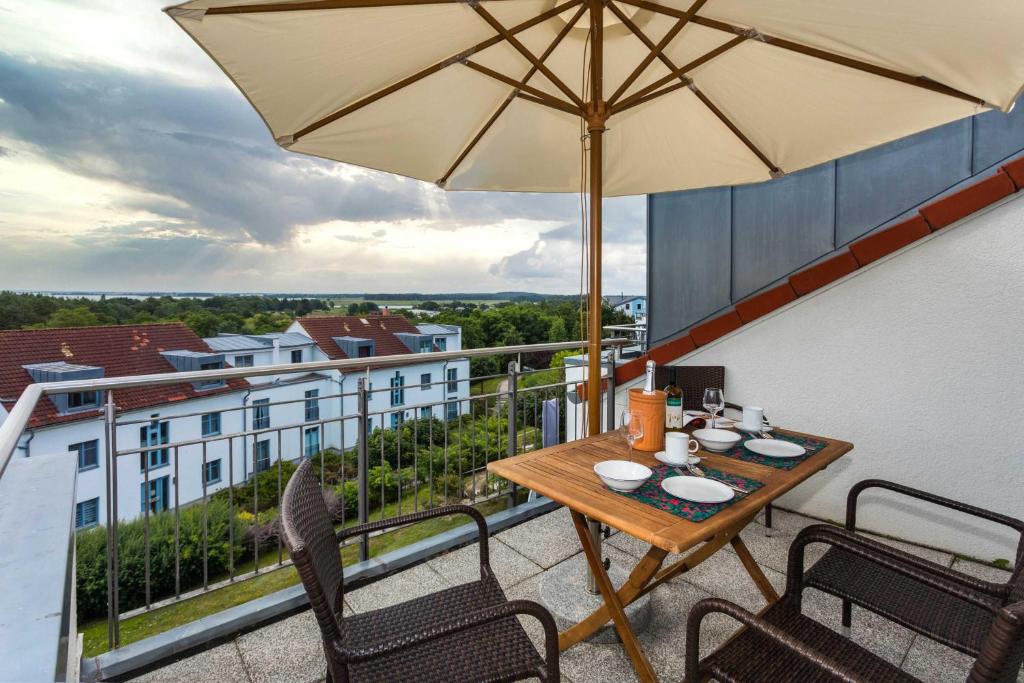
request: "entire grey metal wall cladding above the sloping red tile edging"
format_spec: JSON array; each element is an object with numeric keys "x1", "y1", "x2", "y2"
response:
[{"x1": 647, "y1": 94, "x2": 1024, "y2": 343}]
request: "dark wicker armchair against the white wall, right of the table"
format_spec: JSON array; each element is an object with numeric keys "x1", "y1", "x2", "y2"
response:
[{"x1": 805, "y1": 479, "x2": 1024, "y2": 656}]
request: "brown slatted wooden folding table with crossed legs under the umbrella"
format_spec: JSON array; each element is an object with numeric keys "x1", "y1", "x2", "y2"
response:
[{"x1": 487, "y1": 430, "x2": 853, "y2": 681}]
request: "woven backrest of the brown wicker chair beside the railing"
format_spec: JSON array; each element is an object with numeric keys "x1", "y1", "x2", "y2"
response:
[{"x1": 281, "y1": 460, "x2": 344, "y2": 640}]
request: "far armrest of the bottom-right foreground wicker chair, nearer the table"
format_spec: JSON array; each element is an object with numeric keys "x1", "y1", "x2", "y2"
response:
[{"x1": 785, "y1": 524, "x2": 1009, "y2": 611}]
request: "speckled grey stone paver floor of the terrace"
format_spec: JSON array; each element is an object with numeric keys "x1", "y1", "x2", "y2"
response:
[{"x1": 134, "y1": 510, "x2": 1024, "y2": 683}]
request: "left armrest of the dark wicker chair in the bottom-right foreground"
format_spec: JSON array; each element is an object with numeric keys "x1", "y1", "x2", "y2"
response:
[{"x1": 684, "y1": 598, "x2": 868, "y2": 683}]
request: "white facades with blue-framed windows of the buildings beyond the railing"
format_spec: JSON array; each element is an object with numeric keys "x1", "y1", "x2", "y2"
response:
[{"x1": 0, "y1": 326, "x2": 469, "y2": 525}]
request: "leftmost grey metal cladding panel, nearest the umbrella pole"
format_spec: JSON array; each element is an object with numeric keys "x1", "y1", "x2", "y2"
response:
[{"x1": 647, "y1": 187, "x2": 732, "y2": 339}]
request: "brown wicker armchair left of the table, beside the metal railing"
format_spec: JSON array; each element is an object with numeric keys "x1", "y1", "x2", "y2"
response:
[{"x1": 281, "y1": 461, "x2": 559, "y2": 683}]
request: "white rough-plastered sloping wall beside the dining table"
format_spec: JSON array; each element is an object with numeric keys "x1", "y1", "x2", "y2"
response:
[{"x1": 618, "y1": 193, "x2": 1024, "y2": 561}]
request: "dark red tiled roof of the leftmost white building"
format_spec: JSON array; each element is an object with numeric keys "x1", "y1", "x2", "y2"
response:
[{"x1": 0, "y1": 323, "x2": 249, "y2": 427}]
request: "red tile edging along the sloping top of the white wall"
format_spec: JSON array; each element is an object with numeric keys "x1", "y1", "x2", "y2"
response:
[{"x1": 615, "y1": 157, "x2": 1024, "y2": 384}]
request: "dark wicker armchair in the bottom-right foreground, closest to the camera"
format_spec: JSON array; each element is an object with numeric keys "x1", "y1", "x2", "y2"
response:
[{"x1": 685, "y1": 524, "x2": 1024, "y2": 683}]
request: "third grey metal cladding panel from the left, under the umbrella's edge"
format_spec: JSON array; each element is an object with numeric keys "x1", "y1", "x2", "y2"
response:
[{"x1": 836, "y1": 119, "x2": 970, "y2": 246}]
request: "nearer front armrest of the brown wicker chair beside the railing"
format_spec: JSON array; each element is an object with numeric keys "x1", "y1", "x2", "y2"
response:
[{"x1": 334, "y1": 600, "x2": 559, "y2": 681}]
